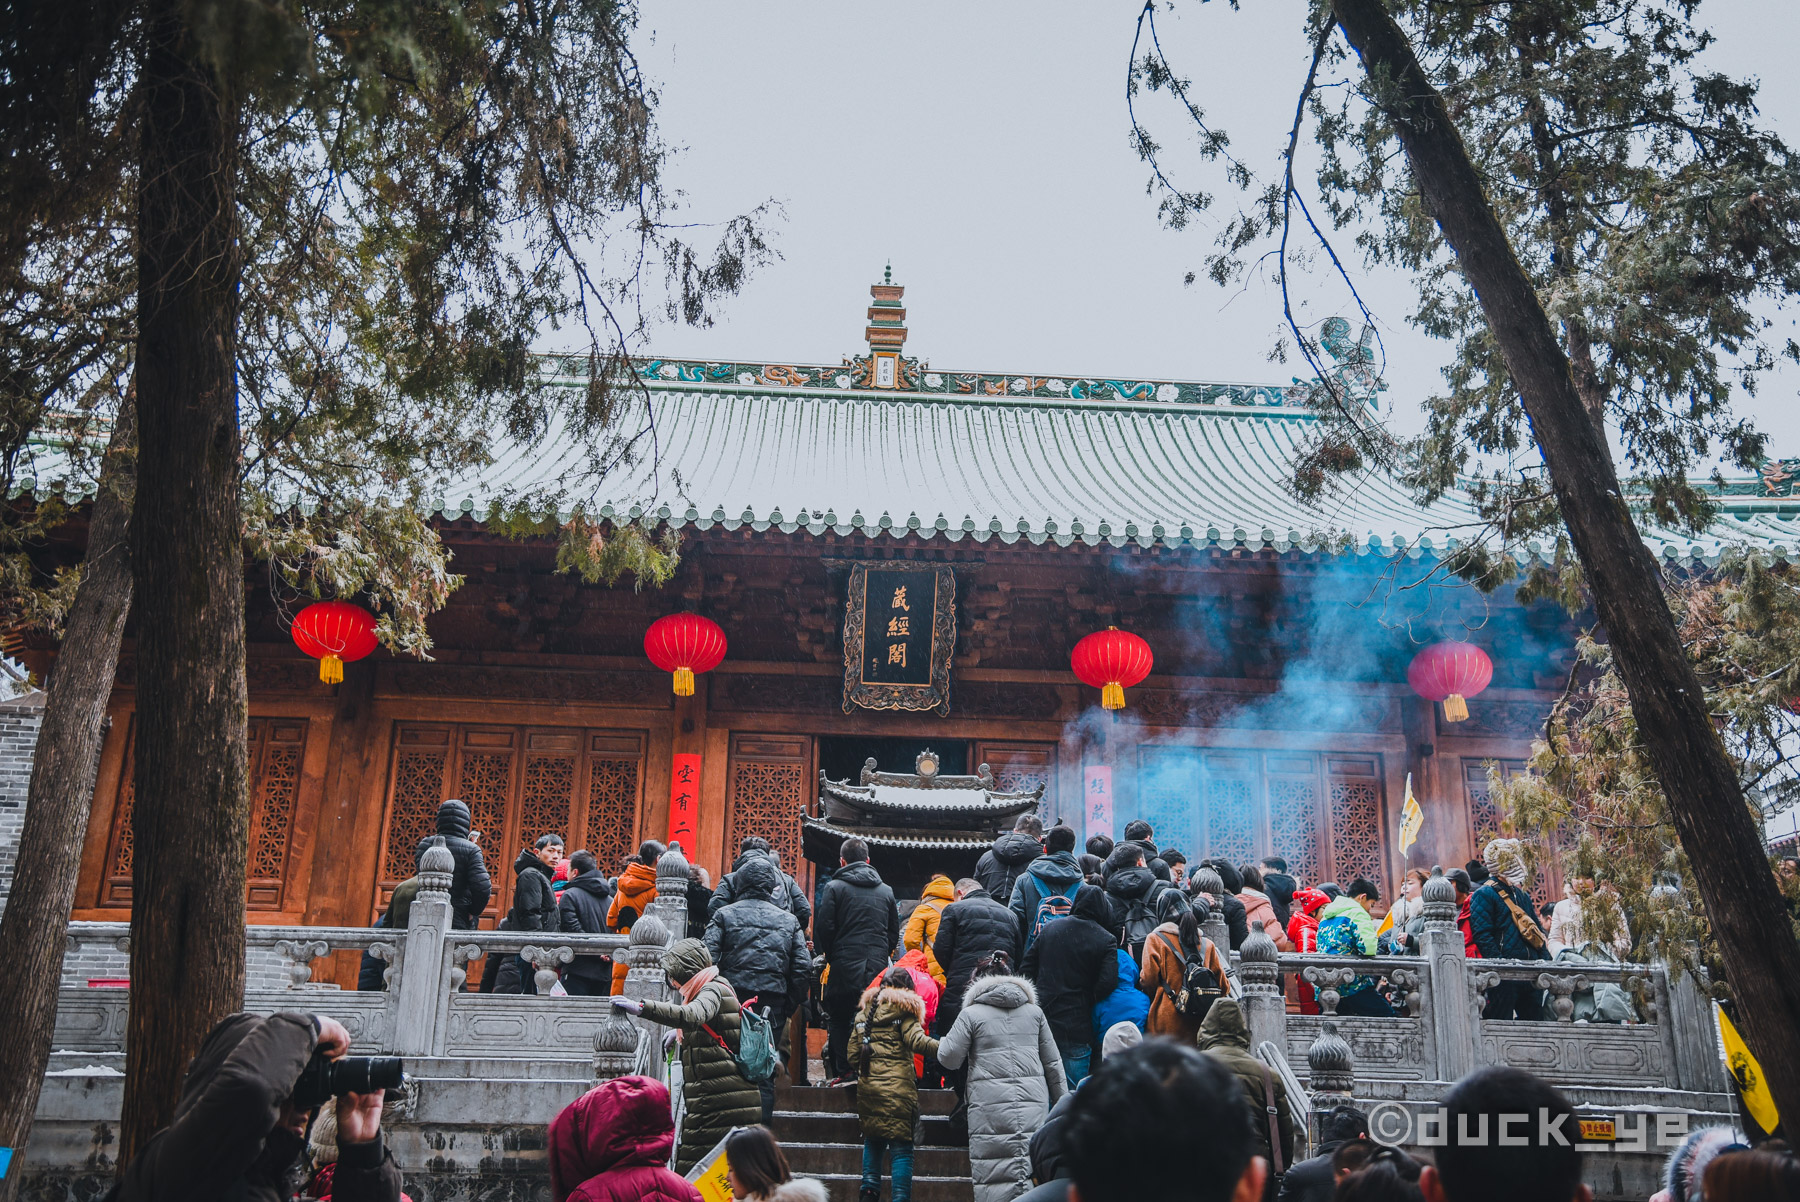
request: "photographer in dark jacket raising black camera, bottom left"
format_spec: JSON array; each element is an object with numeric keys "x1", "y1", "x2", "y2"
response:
[{"x1": 113, "y1": 1013, "x2": 403, "y2": 1202}]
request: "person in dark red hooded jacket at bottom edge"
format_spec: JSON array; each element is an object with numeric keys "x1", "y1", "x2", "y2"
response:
[{"x1": 549, "y1": 1076, "x2": 702, "y2": 1202}]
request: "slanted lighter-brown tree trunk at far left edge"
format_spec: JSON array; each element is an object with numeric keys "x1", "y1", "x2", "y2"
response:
[{"x1": 0, "y1": 392, "x2": 137, "y2": 1202}]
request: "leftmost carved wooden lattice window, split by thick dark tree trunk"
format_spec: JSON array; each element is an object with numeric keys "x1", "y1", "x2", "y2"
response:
[{"x1": 99, "y1": 716, "x2": 308, "y2": 910}]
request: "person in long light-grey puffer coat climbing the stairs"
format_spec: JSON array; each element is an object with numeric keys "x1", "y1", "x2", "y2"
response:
[{"x1": 938, "y1": 975, "x2": 1067, "y2": 1202}]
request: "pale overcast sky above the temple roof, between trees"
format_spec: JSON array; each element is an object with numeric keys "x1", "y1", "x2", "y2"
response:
[{"x1": 608, "y1": 0, "x2": 1800, "y2": 453}]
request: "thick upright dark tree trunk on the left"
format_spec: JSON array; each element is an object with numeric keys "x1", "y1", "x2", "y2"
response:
[{"x1": 119, "y1": 0, "x2": 248, "y2": 1164}]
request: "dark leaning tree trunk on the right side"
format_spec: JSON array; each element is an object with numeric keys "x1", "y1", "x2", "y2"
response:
[{"x1": 1332, "y1": 0, "x2": 1800, "y2": 1123}]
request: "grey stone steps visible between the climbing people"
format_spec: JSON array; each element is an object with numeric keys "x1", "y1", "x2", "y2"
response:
[{"x1": 774, "y1": 1085, "x2": 976, "y2": 1202}]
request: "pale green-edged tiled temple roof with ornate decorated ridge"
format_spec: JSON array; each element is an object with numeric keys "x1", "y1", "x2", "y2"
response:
[{"x1": 414, "y1": 360, "x2": 1800, "y2": 561}]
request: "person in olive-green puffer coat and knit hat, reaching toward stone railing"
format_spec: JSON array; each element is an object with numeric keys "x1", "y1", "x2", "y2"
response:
[{"x1": 612, "y1": 939, "x2": 763, "y2": 1175}]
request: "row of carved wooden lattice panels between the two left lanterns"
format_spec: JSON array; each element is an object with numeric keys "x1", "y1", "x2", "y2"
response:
[{"x1": 376, "y1": 723, "x2": 644, "y2": 914}]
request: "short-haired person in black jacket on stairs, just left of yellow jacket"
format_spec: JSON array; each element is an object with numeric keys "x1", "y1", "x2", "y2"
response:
[{"x1": 812, "y1": 839, "x2": 900, "y2": 1080}]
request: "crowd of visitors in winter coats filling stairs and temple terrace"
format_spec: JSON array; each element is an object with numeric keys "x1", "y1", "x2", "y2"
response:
[{"x1": 288, "y1": 801, "x2": 1796, "y2": 1202}]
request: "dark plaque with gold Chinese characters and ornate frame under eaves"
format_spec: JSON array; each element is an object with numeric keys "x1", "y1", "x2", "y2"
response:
[{"x1": 844, "y1": 561, "x2": 956, "y2": 714}]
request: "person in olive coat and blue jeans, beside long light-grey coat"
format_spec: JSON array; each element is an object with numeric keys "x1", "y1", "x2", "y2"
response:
[{"x1": 850, "y1": 968, "x2": 938, "y2": 1202}]
